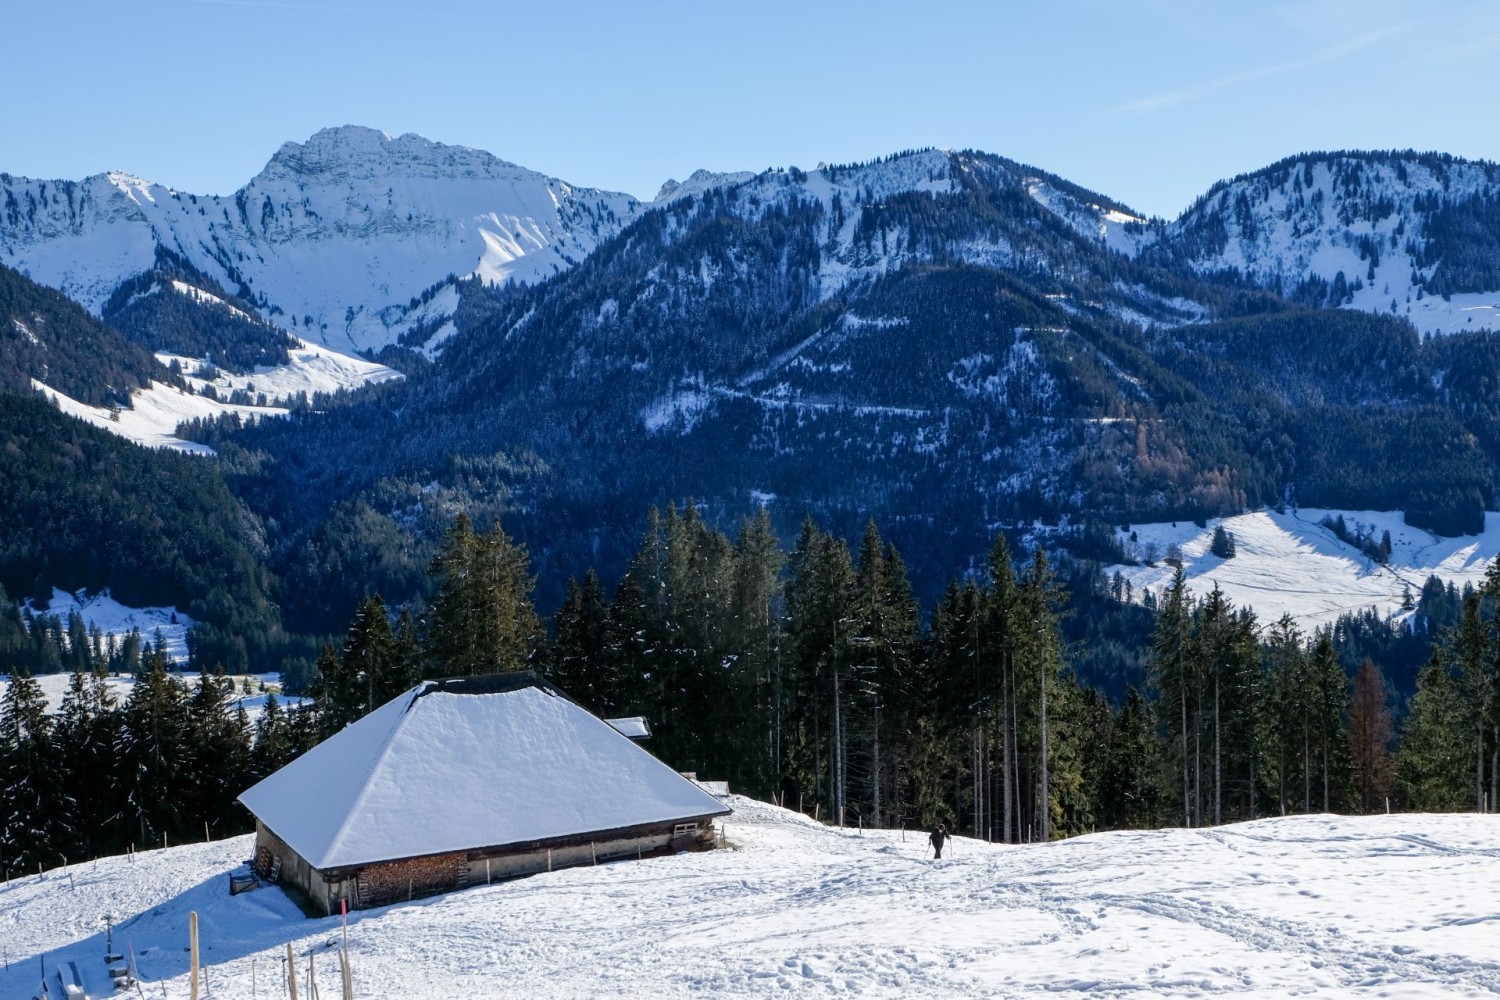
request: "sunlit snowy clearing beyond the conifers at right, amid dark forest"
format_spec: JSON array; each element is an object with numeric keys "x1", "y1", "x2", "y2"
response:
[{"x1": 1109, "y1": 507, "x2": 1500, "y2": 630}]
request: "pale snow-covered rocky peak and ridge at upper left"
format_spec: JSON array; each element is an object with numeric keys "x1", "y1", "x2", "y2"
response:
[{"x1": 0, "y1": 126, "x2": 641, "y2": 351}]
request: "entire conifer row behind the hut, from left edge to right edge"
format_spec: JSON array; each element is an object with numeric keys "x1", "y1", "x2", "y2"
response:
[{"x1": 0, "y1": 504, "x2": 1500, "y2": 873}]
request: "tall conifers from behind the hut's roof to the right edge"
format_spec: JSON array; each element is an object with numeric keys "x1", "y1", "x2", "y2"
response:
[{"x1": 286, "y1": 504, "x2": 1500, "y2": 841}]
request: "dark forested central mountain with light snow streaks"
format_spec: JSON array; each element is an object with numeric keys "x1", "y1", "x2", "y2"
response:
[{"x1": 215, "y1": 150, "x2": 1496, "y2": 626}]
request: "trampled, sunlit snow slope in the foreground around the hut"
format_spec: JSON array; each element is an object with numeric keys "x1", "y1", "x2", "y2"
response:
[{"x1": 0, "y1": 798, "x2": 1500, "y2": 1000}]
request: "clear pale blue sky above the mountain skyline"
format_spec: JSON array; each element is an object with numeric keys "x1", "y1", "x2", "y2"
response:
[{"x1": 0, "y1": 0, "x2": 1500, "y2": 217}]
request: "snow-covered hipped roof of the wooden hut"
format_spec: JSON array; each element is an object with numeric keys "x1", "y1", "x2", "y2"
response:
[{"x1": 240, "y1": 673, "x2": 729, "y2": 870}]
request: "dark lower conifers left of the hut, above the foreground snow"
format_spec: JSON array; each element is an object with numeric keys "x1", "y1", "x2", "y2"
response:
[{"x1": 0, "y1": 656, "x2": 318, "y2": 877}]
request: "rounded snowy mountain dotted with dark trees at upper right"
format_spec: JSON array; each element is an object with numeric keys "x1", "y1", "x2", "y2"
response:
[{"x1": 1157, "y1": 153, "x2": 1500, "y2": 333}]
